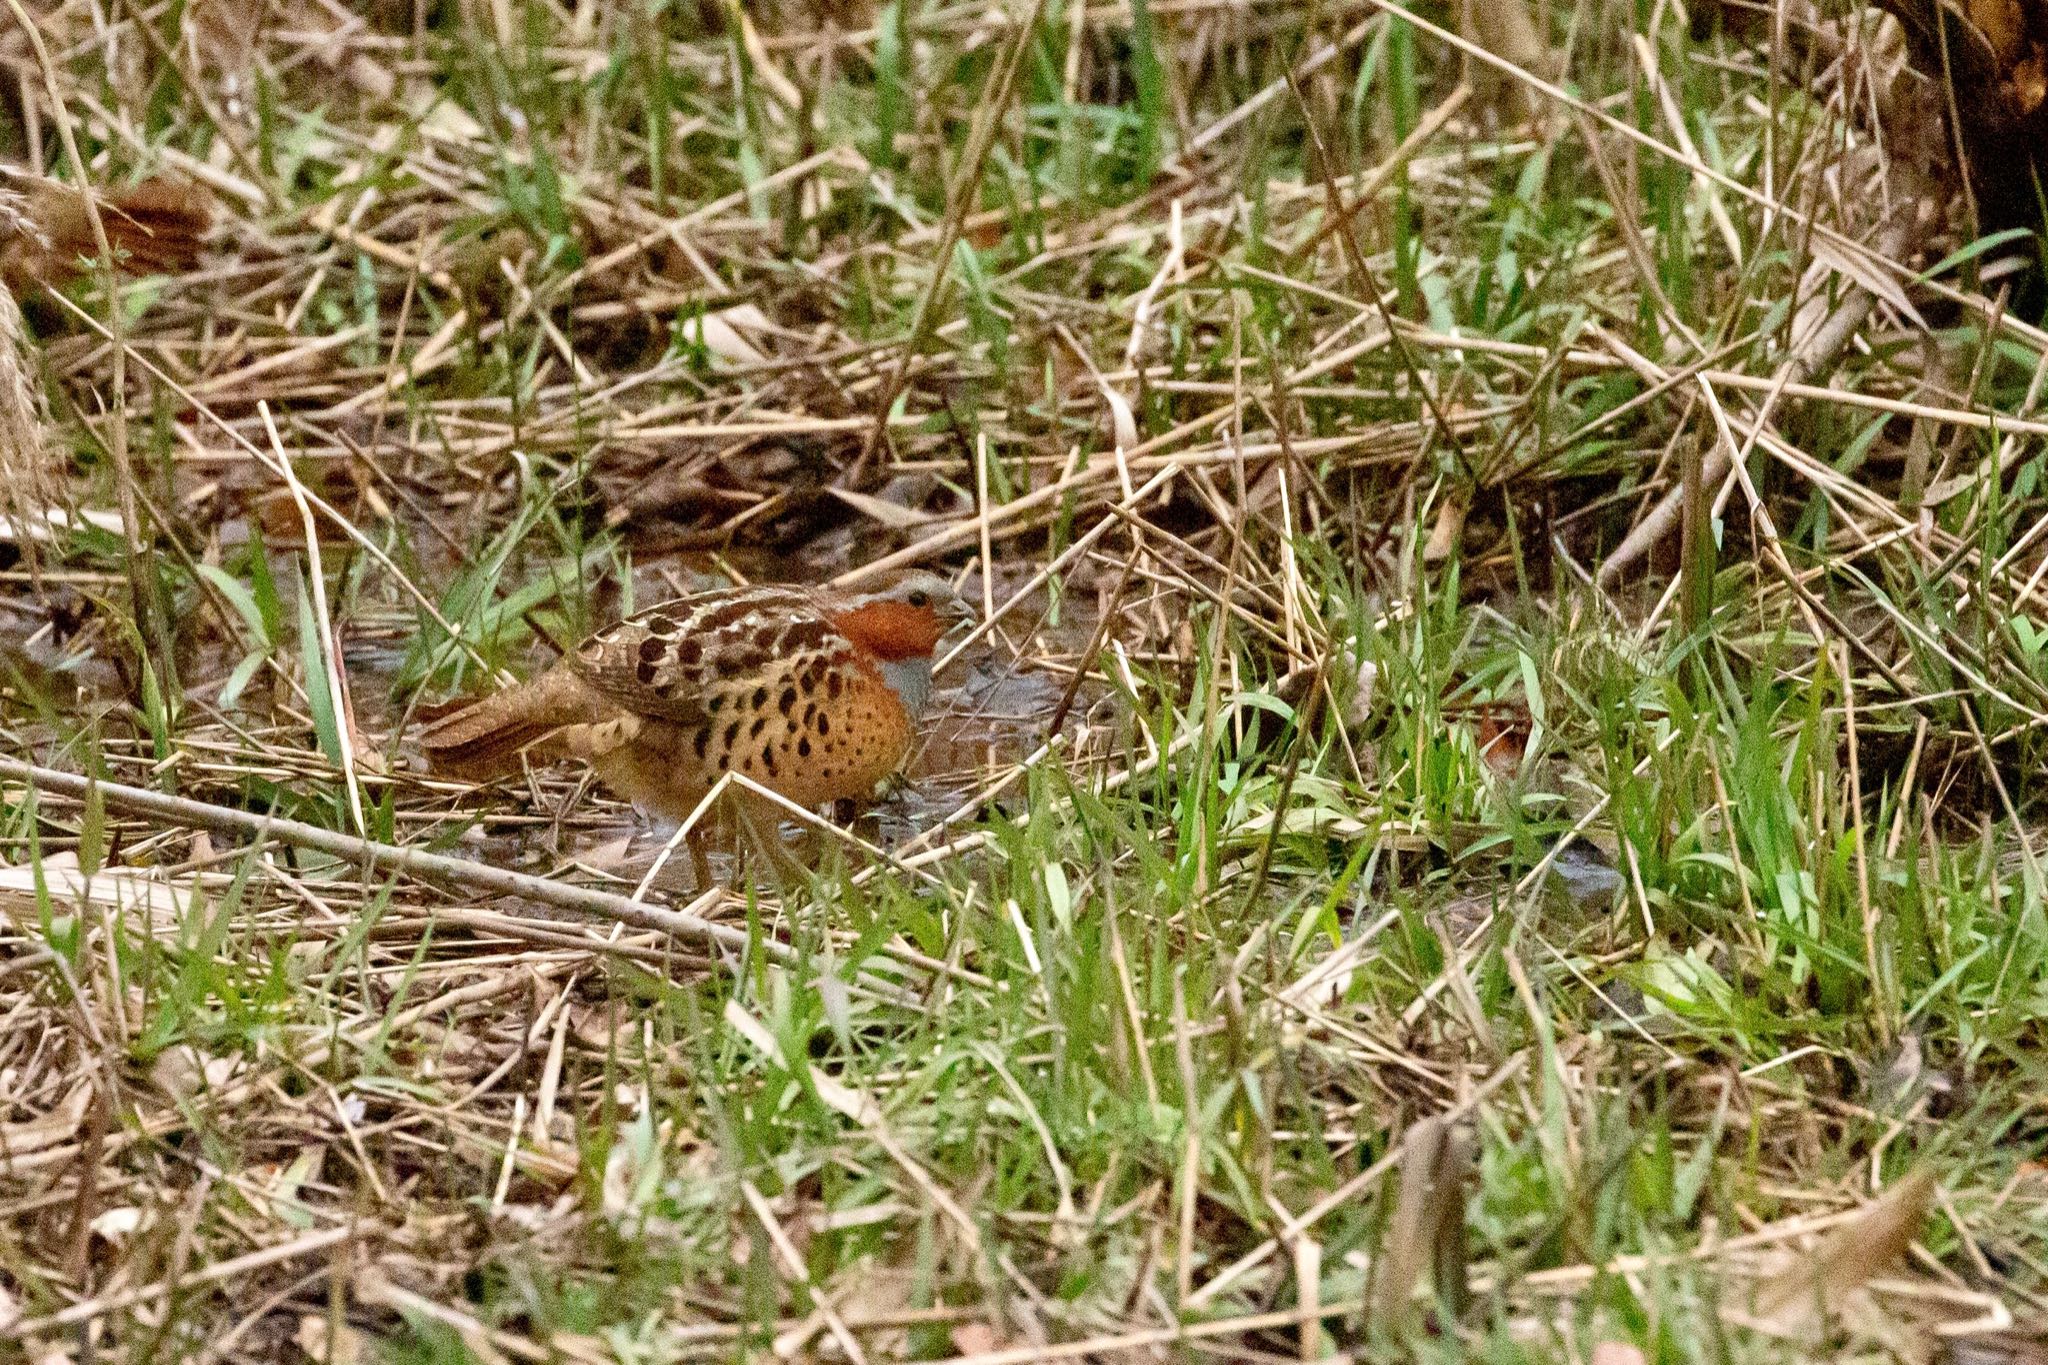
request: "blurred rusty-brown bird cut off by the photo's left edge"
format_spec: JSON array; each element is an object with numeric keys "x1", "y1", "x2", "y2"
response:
[{"x1": 0, "y1": 166, "x2": 213, "y2": 295}]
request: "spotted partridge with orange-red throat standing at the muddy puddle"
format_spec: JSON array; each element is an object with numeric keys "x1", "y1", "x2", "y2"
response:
[{"x1": 420, "y1": 569, "x2": 975, "y2": 888}]
